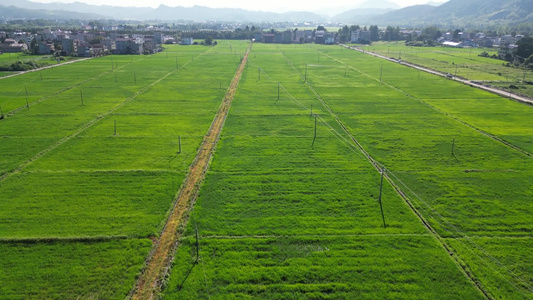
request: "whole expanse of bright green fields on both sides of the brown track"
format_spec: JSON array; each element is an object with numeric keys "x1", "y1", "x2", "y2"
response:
[{"x1": 0, "y1": 41, "x2": 533, "y2": 299}]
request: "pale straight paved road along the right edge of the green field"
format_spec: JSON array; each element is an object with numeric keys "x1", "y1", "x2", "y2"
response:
[{"x1": 341, "y1": 45, "x2": 533, "y2": 105}]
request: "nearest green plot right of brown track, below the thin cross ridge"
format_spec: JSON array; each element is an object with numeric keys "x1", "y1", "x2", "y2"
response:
[{"x1": 164, "y1": 235, "x2": 482, "y2": 299}]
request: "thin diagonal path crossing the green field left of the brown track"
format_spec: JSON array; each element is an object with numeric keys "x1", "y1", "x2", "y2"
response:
[{"x1": 0, "y1": 55, "x2": 190, "y2": 183}]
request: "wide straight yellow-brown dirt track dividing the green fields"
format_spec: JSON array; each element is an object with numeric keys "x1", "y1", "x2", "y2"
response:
[{"x1": 131, "y1": 44, "x2": 253, "y2": 299}]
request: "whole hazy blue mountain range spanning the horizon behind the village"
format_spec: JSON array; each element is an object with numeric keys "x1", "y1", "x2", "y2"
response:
[{"x1": 0, "y1": 0, "x2": 533, "y2": 28}]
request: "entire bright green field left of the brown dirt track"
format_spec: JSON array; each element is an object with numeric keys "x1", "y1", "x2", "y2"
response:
[{"x1": 0, "y1": 42, "x2": 246, "y2": 299}]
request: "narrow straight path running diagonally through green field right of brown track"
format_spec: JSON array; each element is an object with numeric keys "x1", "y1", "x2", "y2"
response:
[{"x1": 281, "y1": 52, "x2": 492, "y2": 299}]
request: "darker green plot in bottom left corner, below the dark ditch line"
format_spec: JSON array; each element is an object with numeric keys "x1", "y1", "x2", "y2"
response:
[{"x1": 0, "y1": 239, "x2": 151, "y2": 299}]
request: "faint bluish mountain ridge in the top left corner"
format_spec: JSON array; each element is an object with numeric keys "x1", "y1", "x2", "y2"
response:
[{"x1": 0, "y1": 5, "x2": 103, "y2": 20}]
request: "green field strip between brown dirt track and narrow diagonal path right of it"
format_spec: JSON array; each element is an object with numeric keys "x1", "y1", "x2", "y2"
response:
[{"x1": 164, "y1": 44, "x2": 481, "y2": 299}]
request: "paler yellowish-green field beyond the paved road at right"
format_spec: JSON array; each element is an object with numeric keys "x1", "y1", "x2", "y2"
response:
[{"x1": 362, "y1": 42, "x2": 533, "y2": 97}]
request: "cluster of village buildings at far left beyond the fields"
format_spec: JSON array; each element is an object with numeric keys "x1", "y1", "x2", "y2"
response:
[{"x1": 0, "y1": 29, "x2": 176, "y2": 57}]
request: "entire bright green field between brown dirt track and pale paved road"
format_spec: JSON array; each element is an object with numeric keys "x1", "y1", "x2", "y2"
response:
[{"x1": 164, "y1": 44, "x2": 533, "y2": 299}]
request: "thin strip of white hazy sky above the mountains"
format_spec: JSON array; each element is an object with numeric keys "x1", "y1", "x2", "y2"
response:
[{"x1": 33, "y1": 0, "x2": 436, "y2": 12}]
